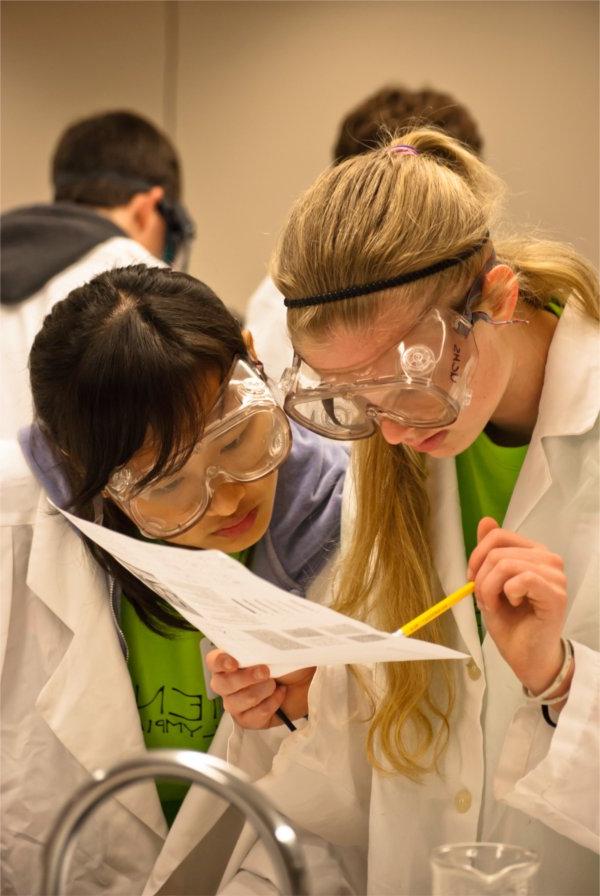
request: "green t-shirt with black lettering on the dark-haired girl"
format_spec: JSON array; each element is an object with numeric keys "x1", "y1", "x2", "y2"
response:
[{"x1": 121, "y1": 550, "x2": 249, "y2": 827}]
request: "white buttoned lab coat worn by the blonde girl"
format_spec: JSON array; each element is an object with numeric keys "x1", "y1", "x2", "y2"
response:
[{"x1": 223, "y1": 308, "x2": 600, "y2": 896}]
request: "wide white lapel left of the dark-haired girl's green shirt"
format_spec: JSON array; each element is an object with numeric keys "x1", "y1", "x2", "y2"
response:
[{"x1": 27, "y1": 496, "x2": 166, "y2": 838}]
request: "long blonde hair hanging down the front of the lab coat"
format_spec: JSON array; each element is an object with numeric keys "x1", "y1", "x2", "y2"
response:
[{"x1": 335, "y1": 433, "x2": 454, "y2": 779}]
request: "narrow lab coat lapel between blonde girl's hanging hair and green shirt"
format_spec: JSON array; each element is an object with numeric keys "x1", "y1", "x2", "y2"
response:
[{"x1": 429, "y1": 457, "x2": 481, "y2": 664}]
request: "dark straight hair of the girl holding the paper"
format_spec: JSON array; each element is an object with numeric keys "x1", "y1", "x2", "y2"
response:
[{"x1": 29, "y1": 265, "x2": 247, "y2": 632}]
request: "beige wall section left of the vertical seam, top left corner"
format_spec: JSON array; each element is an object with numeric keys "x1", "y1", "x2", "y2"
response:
[{"x1": 1, "y1": 0, "x2": 166, "y2": 209}]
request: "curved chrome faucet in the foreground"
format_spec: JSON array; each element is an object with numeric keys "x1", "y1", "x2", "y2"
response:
[{"x1": 42, "y1": 750, "x2": 308, "y2": 896}]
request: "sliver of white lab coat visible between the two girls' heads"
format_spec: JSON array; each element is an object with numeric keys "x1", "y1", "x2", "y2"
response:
[{"x1": 245, "y1": 277, "x2": 294, "y2": 382}]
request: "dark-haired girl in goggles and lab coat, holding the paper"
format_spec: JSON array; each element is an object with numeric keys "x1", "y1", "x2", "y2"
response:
[{"x1": 0, "y1": 265, "x2": 347, "y2": 896}]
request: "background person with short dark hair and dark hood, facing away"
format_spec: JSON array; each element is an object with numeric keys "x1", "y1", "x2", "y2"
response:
[{"x1": 0, "y1": 111, "x2": 194, "y2": 438}]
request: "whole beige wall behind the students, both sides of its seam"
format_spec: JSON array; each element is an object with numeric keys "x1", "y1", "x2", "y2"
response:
[{"x1": 2, "y1": 0, "x2": 599, "y2": 309}]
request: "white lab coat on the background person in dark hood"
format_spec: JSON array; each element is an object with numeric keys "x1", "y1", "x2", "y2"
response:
[{"x1": 0, "y1": 236, "x2": 162, "y2": 439}]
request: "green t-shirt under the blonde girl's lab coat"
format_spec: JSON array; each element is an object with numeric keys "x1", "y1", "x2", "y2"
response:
[{"x1": 456, "y1": 432, "x2": 529, "y2": 641}]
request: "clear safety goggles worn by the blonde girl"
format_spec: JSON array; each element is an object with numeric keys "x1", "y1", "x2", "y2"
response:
[{"x1": 281, "y1": 277, "x2": 524, "y2": 440}]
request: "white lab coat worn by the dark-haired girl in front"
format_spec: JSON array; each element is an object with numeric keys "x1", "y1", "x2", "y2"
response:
[{"x1": 0, "y1": 441, "x2": 338, "y2": 896}]
